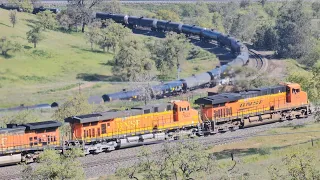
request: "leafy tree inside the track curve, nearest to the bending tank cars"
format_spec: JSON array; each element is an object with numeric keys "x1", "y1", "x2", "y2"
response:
[{"x1": 152, "y1": 33, "x2": 191, "y2": 77}]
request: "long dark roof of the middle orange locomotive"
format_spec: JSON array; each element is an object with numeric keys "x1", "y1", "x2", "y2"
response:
[{"x1": 64, "y1": 103, "x2": 173, "y2": 124}]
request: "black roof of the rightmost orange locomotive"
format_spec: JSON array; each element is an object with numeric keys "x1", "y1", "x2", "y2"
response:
[{"x1": 195, "y1": 85, "x2": 286, "y2": 105}]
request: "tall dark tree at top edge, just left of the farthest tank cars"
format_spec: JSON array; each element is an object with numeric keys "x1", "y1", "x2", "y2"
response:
[{"x1": 67, "y1": 0, "x2": 102, "y2": 32}]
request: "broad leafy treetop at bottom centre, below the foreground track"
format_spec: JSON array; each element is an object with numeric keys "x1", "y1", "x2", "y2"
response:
[{"x1": 116, "y1": 141, "x2": 225, "y2": 179}]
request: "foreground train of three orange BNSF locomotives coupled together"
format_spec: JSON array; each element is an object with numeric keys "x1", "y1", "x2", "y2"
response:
[{"x1": 0, "y1": 83, "x2": 311, "y2": 165}]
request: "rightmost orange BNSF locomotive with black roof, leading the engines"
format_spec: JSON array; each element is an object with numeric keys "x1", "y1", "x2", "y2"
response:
[{"x1": 195, "y1": 83, "x2": 311, "y2": 133}]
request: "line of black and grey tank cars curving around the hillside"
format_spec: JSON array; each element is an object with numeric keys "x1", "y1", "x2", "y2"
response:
[{"x1": 95, "y1": 12, "x2": 249, "y2": 102}]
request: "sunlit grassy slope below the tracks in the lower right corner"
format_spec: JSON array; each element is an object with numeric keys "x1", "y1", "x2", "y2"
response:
[{"x1": 212, "y1": 123, "x2": 320, "y2": 179}]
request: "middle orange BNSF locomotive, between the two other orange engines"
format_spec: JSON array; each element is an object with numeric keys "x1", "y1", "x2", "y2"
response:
[{"x1": 65, "y1": 101, "x2": 200, "y2": 154}]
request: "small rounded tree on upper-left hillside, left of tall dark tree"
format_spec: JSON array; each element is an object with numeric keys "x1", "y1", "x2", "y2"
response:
[{"x1": 37, "y1": 10, "x2": 57, "y2": 30}]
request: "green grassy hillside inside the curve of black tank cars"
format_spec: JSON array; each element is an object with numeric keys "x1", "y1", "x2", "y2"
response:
[{"x1": 0, "y1": 9, "x2": 218, "y2": 108}]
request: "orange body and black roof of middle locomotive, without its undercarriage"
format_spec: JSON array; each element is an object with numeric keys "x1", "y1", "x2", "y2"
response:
[{"x1": 65, "y1": 101, "x2": 199, "y2": 142}]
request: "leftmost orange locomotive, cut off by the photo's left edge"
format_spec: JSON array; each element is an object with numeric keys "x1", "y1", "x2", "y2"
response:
[{"x1": 0, "y1": 121, "x2": 61, "y2": 165}]
